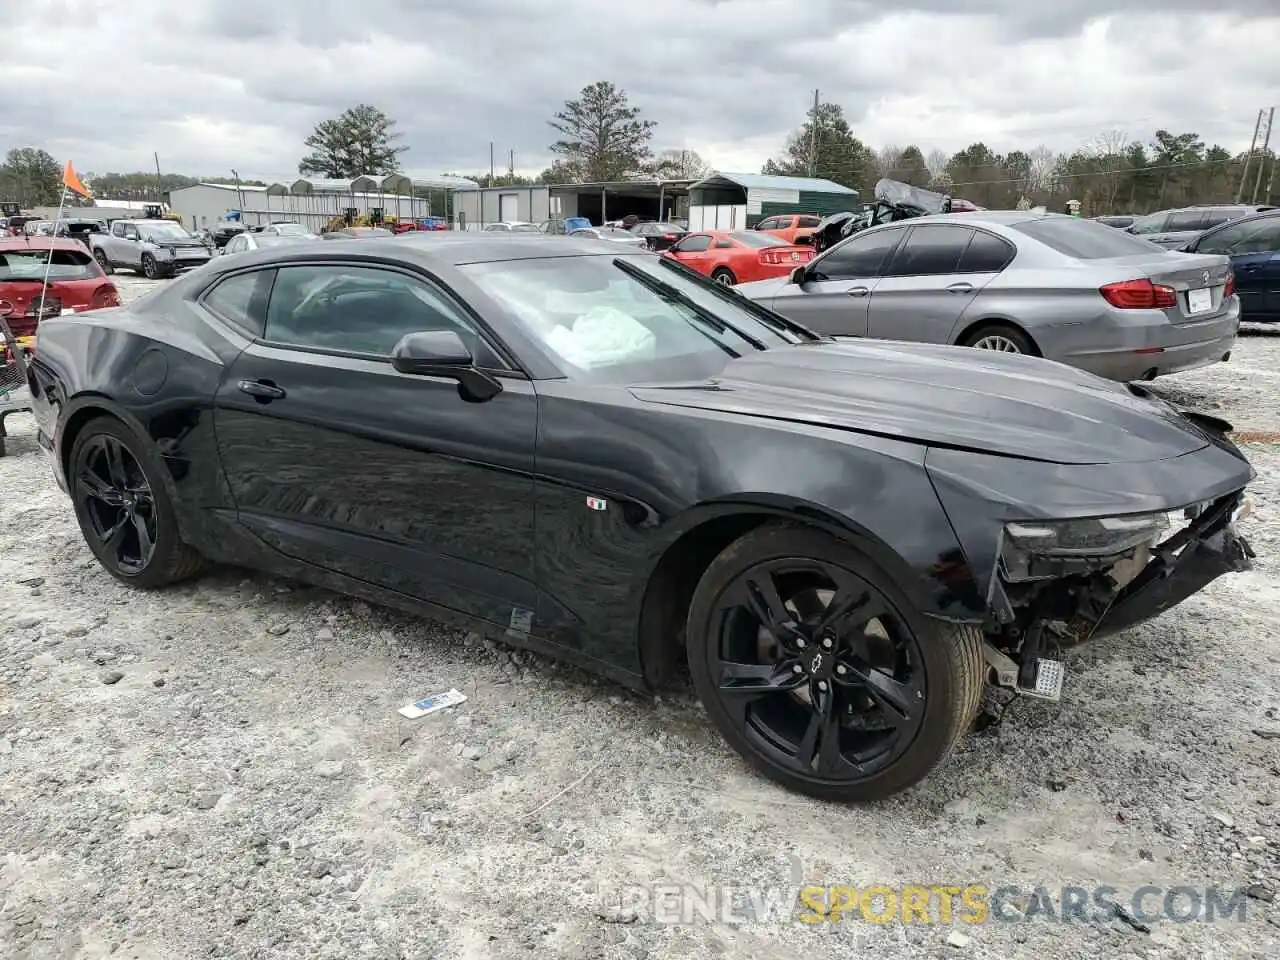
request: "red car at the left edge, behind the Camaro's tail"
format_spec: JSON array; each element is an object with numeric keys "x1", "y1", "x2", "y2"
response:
[{"x1": 0, "y1": 237, "x2": 120, "y2": 338}]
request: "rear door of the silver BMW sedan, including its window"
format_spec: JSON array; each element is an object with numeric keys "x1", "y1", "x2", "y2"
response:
[{"x1": 868, "y1": 224, "x2": 995, "y2": 343}]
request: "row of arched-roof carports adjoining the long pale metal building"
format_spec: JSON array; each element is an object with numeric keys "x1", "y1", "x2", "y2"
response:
[{"x1": 259, "y1": 173, "x2": 480, "y2": 223}]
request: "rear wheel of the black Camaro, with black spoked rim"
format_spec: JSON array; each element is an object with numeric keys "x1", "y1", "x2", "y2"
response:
[{"x1": 67, "y1": 416, "x2": 204, "y2": 590}]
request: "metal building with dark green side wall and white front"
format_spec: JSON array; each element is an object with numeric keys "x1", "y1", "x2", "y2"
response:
[{"x1": 689, "y1": 173, "x2": 863, "y2": 230}]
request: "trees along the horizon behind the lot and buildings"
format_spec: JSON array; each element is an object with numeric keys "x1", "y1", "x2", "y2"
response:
[{"x1": 0, "y1": 81, "x2": 1280, "y2": 216}]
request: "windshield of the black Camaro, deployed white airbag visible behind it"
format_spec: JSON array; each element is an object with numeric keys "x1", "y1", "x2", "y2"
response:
[{"x1": 460, "y1": 255, "x2": 812, "y2": 384}]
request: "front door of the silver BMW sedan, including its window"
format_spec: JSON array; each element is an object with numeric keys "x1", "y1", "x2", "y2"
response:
[{"x1": 773, "y1": 227, "x2": 906, "y2": 337}]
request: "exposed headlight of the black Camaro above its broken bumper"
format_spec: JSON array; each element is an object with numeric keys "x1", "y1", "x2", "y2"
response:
[{"x1": 1000, "y1": 512, "x2": 1169, "y2": 581}]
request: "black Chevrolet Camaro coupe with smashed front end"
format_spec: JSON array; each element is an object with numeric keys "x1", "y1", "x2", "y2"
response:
[{"x1": 29, "y1": 233, "x2": 1253, "y2": 800}]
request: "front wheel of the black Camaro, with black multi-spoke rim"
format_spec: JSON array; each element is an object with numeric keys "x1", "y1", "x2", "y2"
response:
[{"x1": 687, "y1": 524, "x2": 983, "y2": 803}]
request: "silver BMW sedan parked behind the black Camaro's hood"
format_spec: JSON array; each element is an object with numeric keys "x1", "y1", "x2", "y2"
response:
[{"x1": 736, "y1": 211, "x2": 1240, "y2": 380}]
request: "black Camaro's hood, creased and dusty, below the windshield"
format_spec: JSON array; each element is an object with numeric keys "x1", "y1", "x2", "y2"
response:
[{"x1": 632, "y1": 340, "x2": 1208, "y2": 463}]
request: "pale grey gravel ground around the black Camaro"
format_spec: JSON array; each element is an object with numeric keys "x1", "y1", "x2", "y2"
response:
[{"x1": 0, "y1": 278, "x2": 1280, "y2": 960}]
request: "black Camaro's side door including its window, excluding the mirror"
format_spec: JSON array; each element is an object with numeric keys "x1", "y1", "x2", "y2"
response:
[{"x1": 207, "y1": 261, "x2": 536, "y2": 632}]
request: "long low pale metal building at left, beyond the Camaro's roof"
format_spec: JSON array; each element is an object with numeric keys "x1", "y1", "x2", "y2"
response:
[{"x1": 169, "y1": 174, "x2": 479, "y2": 232}]
